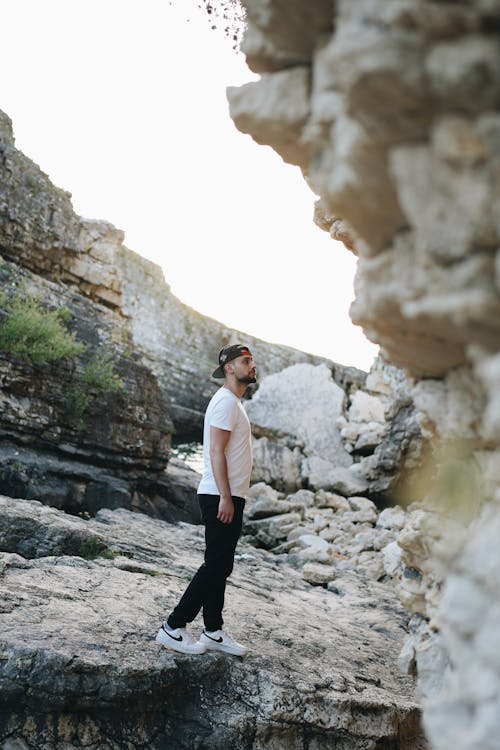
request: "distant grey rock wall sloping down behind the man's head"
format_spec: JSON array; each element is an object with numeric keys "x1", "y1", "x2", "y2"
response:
[{"x1": 117, "y1": 249, "x2": 344, "y2": 440}]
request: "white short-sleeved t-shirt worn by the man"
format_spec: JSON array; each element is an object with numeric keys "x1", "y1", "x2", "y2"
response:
[{"x1": 198, "y1": 386, "x2": 252, "y2": 498}]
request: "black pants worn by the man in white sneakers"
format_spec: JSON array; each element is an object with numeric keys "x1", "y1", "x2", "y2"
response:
[{"x1": 167, "y1": 495, "x2": 245, "y2": 631}]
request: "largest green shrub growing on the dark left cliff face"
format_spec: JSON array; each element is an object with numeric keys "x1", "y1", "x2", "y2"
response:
[{"x1": 0, "y1": 292, "x2": 84, "y2": 364}]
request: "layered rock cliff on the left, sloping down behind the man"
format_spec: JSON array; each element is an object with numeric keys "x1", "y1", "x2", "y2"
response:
[{"x1": 0, "y1": 113, "x2": 350, "y2": 521}]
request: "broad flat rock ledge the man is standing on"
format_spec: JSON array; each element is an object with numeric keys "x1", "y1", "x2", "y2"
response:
[{"x1": 0, "y1": 497, "x2": 426, "y2": 750}]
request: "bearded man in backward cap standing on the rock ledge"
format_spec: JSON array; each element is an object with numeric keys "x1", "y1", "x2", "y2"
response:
[{"x1": 156, "y1": 344, "x2": 257, "y2": 656}]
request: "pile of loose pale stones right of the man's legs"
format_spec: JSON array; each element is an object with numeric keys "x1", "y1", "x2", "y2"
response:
[{"x1": 245, "y1": 483, "x2": 410, "y2": 584}]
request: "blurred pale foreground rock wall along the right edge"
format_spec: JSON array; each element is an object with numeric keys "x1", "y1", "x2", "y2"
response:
[{"x1": 228, "y1": 0, "x2": 500, "y2": 750}]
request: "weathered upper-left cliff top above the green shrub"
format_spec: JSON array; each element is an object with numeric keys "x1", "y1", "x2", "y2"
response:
[{"x1": 0, "y1": 112, "x2": 123, "y2": 308}]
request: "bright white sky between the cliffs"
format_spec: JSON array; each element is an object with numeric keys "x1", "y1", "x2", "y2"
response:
[{"x1": 0, "y1": 0, "x2": 377, "y2": 369}]
